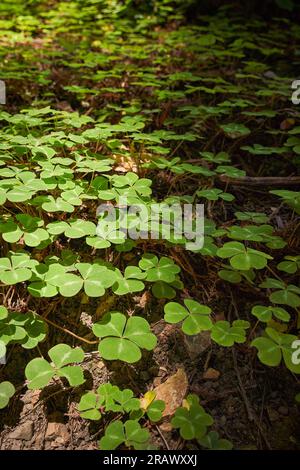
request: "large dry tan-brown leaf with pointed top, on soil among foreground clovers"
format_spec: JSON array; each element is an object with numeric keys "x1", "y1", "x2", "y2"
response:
[{"x1": 154, "y1": 369, "x2": 188, "y2": 416}]
